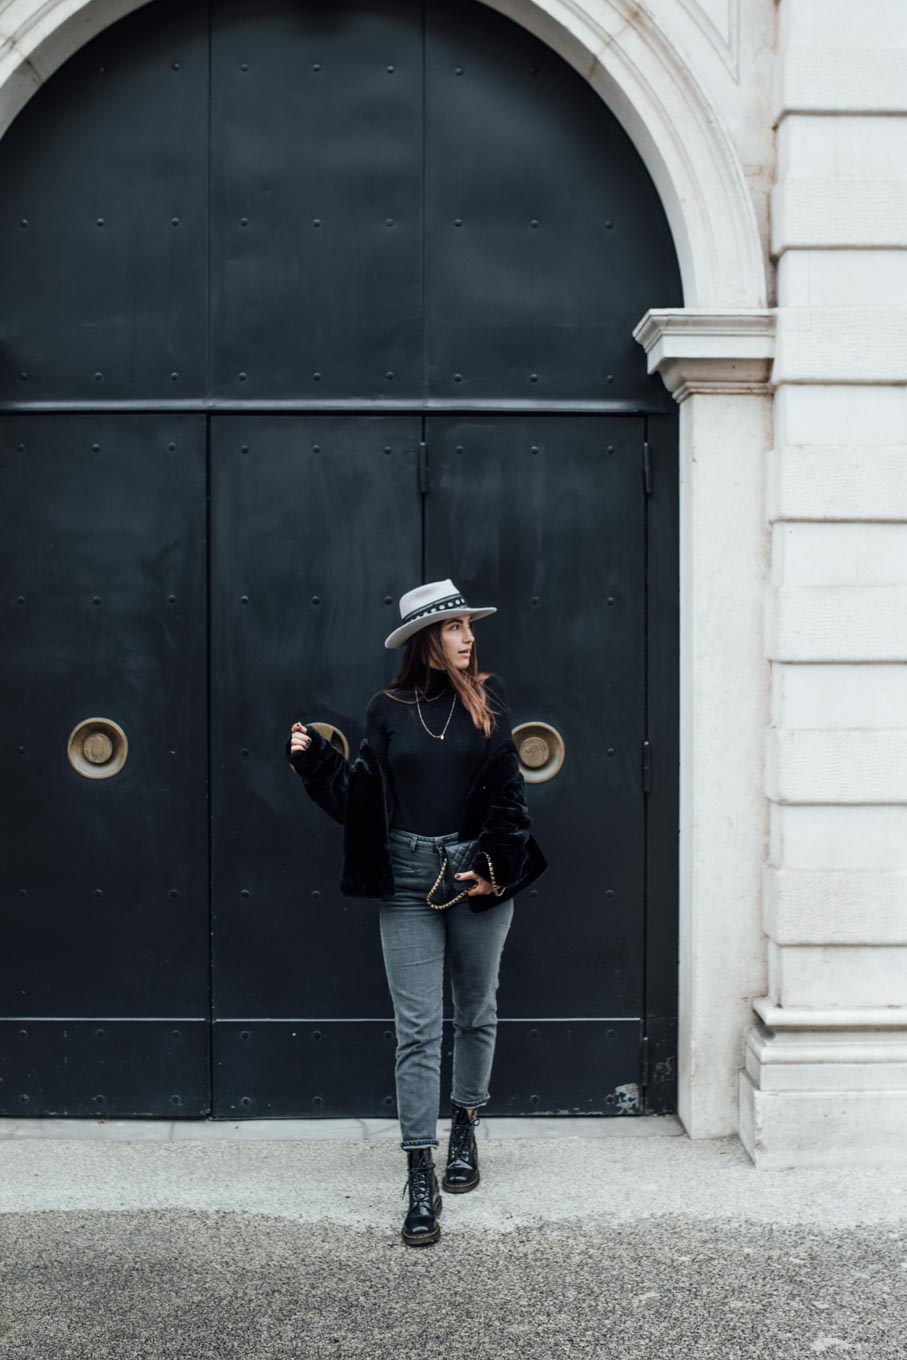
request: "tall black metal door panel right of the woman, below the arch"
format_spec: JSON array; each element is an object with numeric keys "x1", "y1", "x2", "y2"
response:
[{"x1": 426, "y1": 416, "x2": 646, "y2": 1017}]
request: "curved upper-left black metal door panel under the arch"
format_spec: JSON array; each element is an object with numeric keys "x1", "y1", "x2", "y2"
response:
[{"x1": 0, "y1": 0, "x2": 208, "y2": 404}]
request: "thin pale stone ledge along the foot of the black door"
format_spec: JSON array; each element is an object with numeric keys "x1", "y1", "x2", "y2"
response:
[{"x1": 0, "y1": 1115, "x2": 684, "y2": 1142}]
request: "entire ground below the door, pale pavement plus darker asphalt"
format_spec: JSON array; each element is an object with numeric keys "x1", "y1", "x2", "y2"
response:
[{"x1": 0, "y1": 1121, "x2": 907, "y2": 1360}]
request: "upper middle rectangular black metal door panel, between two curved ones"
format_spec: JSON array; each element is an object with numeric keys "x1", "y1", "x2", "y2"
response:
[{"x1": 211, "y1": 0, "x2": 423, "y2": 400}]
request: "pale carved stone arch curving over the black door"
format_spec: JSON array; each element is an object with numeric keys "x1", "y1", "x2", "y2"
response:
[{"x1": 0, "y1": 0, "x2": 766, "y2": 309}]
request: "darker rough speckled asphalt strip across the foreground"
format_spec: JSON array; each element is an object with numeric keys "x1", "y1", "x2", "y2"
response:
[{"x1": 0, "y1": 1213, "x2": 907, "y2": 1360}]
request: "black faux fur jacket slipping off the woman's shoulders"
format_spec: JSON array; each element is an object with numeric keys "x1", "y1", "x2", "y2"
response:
[{"x1": 286, "y1": 726, "x2": 548, "y2": 911}]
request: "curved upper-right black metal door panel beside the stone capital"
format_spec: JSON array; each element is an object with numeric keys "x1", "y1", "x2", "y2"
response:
[{"x1": 426, "y1": 0, "x2": 683, "y2": 409}]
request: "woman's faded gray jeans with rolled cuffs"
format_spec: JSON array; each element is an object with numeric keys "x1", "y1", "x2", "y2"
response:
[{"x1": 379, "y1": 827, "x2": 514, "y2": 1148}]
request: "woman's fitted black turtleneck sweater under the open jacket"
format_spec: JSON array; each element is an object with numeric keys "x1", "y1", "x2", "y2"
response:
[{"x1": 366, "y1": 669, "x2": 511, "y2": 836}]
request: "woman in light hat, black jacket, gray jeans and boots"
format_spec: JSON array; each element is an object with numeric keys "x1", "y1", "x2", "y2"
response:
[{"x1": 287, "y1": 579, "x2": 547, "y2": 1246}]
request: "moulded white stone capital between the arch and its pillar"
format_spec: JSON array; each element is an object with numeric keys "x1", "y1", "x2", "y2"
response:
[{"x1": 634, "y1": 307, "x2": 775, "y2": 401}]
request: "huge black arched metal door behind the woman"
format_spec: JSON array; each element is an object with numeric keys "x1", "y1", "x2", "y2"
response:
[{"x1": 0, "y1": 0, "x2": 681, "y2": 1118}]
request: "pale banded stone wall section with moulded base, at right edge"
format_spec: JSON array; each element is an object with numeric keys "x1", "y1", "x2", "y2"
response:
[{"x1": 741, "y1": 0, "x2": 907, "y2": 1166}]
